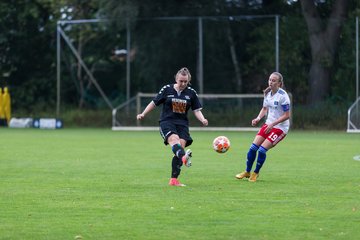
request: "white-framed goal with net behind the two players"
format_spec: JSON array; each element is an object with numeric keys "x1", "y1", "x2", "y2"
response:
[{"x1": 112, "y1": 93, "x2": 264, "y2": 131}]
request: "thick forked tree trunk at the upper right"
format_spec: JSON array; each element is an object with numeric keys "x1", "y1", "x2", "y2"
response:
[{"x1": 301, "y1": 0, "x2": 348, "y2": 103}]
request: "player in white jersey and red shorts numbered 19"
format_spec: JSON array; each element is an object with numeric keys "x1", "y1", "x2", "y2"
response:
[{"x1": 235, "y1": 72, "x2": 290, "y2": 182}]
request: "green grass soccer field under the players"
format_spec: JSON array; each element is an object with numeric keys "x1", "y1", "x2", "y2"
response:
[{"x1": 0, "y1": 129, "x2": 360, "y2": 240}]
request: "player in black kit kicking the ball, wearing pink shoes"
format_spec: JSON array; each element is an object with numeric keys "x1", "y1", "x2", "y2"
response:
[{"x1": 136, "y1": 67, "x2": 208, "y2": 187}]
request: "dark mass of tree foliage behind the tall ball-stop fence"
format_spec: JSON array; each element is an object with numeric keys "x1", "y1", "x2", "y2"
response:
[{"x1": 0, "y1": 0, "x2": 360, "y2": 111}]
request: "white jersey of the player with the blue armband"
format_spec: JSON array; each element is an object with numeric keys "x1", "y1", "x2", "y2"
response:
[{"x1": 263, "y1": 88, "x2": 290, "y2": 133}]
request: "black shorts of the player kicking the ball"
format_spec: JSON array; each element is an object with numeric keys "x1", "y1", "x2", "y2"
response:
[{"x1": 159, "y1": 121, "x2": 193, "y2": 147}]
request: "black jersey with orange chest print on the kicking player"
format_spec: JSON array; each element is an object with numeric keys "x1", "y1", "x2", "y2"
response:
[{"x1": 153, "y1": 84, "x2": 202, "y2": 126}]
